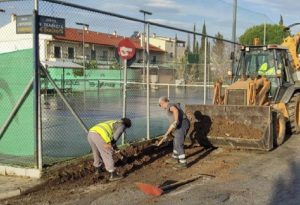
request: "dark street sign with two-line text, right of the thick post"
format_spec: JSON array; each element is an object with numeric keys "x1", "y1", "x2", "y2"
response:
[{"x1": 39, "y1": 16, "x2": 65, "y2": 36}]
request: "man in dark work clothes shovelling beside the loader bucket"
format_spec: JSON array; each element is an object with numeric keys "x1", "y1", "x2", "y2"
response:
[{"x1": 158, "y1": 97, "x2": 190, "y2": 168}]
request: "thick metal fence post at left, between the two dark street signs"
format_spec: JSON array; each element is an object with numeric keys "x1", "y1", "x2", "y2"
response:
[{"x1": 32, "y1": 0, "x2": 43, "y2": 170}]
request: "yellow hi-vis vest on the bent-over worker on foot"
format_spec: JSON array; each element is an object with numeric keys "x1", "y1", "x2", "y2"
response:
[{"x1": 90, "y1": 120, "x2": 117, "y2": 143}]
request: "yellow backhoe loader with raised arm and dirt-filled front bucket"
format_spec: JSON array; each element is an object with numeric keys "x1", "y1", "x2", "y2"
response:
[{"x1": 185, "y1": 33, "x2": 300, "y2": 151}]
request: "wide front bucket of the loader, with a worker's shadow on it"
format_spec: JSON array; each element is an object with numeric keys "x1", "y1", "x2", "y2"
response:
[{"x1": 185, "y1": 105, "x2": 273, "y2": 150}]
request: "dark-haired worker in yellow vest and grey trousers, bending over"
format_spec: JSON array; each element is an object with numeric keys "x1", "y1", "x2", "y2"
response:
[{"x1": 87, "y1": 118, "x2": 131, "y2": 181}]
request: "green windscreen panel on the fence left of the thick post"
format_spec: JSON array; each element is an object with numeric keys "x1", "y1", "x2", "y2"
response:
[{"x1": 0, "y1": 49, "x2": 35, "y2": 166}]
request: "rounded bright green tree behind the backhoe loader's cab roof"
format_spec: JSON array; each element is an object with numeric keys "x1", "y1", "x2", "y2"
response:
[{"x1": 240, "y1": 24, "x2": 290, "y2": 45}]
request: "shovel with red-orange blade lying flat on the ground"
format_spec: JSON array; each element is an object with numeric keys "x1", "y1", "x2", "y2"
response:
[{"x1": 136, "y1": 174, "x2": 215, "y2": 196}]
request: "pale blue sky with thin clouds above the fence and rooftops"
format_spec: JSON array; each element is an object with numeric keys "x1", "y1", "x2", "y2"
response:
[{"x1": 0, "y1": 0, "x2": 300, "y2": 40}]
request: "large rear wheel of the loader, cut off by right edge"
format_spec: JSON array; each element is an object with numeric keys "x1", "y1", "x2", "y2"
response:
[{"x1": 287, "y1": 93, "x2": 300, "y2": 134}]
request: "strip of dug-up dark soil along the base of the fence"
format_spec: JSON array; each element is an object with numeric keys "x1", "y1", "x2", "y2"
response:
[{"x1": 45, "y1": 142, "x2": 171, "y2": 186}]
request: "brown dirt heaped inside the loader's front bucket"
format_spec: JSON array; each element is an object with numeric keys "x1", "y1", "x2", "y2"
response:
[{"x1": 208, "y1": 118, "x2": 263, "y2": 139}]
